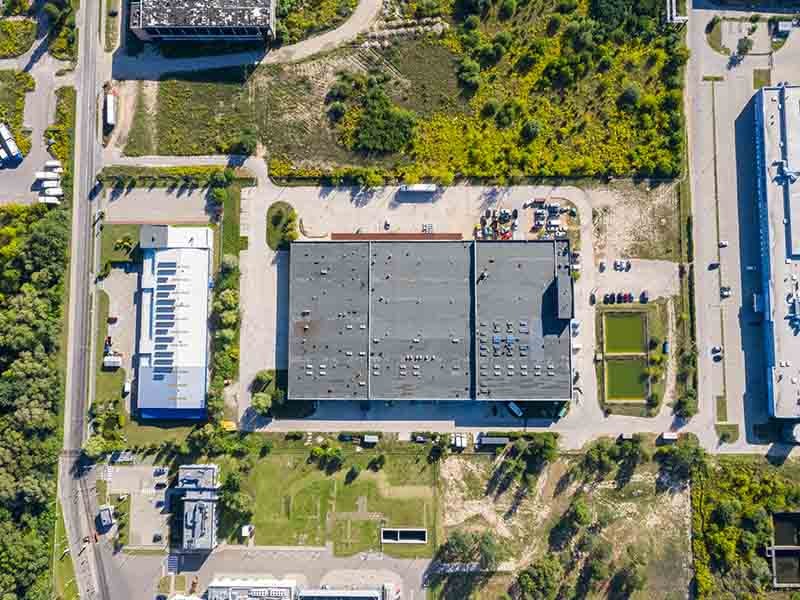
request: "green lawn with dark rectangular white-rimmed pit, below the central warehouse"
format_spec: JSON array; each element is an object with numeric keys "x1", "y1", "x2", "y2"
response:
[{"x1": 232, "y1": 447, "x2": 436, "y2": 556}]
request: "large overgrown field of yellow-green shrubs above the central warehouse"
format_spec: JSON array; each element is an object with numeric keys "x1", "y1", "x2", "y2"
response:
[{"x1": 130, "y1": 0, "x2": 688, "y2": 183}]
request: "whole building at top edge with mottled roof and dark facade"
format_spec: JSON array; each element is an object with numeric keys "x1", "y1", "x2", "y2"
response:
[{"x1": 130, "y1": 0, "x2": 275, "y2": 42}]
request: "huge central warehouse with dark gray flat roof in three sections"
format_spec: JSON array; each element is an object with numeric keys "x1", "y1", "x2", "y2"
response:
[{"x1": 288, "y1": 240, "x2": 573, "y2": 401}]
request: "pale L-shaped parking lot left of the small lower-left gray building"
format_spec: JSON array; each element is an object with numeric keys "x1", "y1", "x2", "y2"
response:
[{"x1": 107, "y1": 465, "x2": 170, "y2": 548}]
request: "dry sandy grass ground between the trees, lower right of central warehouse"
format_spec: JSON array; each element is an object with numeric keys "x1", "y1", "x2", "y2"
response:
[{"x1": 431, "y1": 455, "x2": 691, "y2": 600}]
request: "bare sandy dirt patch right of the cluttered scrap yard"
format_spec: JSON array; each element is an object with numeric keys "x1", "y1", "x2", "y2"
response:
[{"x1": 591, "y1": 184, "x2": 680, "y2": 261}]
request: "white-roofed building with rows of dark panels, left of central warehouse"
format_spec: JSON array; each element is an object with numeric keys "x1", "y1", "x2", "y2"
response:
[{"x1": 136, "y1": 225, "x2": 213, "y2": 419}]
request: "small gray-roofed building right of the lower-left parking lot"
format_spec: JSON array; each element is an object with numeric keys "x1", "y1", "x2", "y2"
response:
[{"x1": 176, "y1": 464, "x2": 219, "y2": 552}]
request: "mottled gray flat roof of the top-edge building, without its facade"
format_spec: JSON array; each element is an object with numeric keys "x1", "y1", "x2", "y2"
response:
[{"x1": 133, "y1": 0, "x2": 272, "y2": 27}]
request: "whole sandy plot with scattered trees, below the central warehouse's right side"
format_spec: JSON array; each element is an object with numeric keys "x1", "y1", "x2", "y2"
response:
[{"x1": 430, "y1": 436, "x2": 696, "y2": 600}]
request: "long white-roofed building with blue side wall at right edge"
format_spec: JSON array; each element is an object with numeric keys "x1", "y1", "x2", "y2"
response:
[{"x1": 754, "y1": 86, "x2": 800, "y2": 419}]
